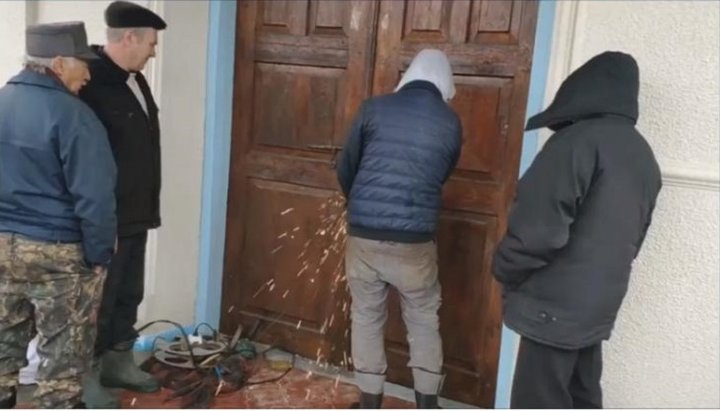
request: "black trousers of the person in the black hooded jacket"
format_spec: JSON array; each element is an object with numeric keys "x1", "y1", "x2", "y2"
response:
[{"x1": 510, "y1": 337, "x2": 602, "y2": 408}]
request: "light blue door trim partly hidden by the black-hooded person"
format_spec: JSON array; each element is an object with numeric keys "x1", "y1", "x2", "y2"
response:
[{"x1": 495, "y1": 0, "x2": 555, "y2": 408}]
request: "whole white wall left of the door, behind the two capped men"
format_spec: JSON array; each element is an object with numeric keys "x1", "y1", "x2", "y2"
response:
[{"x1": 0, "y1": 0, "x2": 209, "y2": 332}]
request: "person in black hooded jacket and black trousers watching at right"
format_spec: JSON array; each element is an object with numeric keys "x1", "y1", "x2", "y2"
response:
[{"x1": 493, "y1": 52, "x2": 661, "y2": 408}]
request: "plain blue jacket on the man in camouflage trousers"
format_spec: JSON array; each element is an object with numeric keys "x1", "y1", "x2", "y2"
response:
[{"x1": 0, "y1": 70, "x2": 116, "y2": 265}]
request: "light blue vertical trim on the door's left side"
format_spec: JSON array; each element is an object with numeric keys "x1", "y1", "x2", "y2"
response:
[{"x1": 195, "y1": 0, "x2": 237, "y2": 327}]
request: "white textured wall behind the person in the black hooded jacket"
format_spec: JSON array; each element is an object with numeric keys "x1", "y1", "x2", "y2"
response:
[{"x1": 545, "y1": 1, "x2": 720, "y2": 408}]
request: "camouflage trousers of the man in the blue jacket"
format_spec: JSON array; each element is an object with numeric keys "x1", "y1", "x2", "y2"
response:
[{"x1": 0, "y1": 233, "x2": 105, "y2": 408}]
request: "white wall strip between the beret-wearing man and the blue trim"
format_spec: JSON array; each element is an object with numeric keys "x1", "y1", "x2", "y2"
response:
[{"x1": 139, "y1": 1, "x2": 208, "y2": 325}]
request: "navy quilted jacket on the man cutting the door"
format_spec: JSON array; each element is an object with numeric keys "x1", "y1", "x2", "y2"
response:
[{"x1": 337, "y1": 80, "x2": 462, "y2": 243}]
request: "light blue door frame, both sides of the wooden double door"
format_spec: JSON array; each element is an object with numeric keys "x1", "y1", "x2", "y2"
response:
[{"x1": 195, "y1": 0, "x2": 556, "y2": 408}]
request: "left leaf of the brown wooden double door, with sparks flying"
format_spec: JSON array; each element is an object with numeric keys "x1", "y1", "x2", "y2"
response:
[{"x1": 221, "y1": 0, "x2": 378, "y2": 362}]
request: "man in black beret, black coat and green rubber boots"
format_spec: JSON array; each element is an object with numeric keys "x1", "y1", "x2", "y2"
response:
[{"x1": 80, "y1": 1, "x2": 166, "y2": 408}]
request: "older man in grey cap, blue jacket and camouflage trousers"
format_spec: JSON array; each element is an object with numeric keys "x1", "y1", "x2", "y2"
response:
[{"x1": 0, "y1": 22, "x2": 116, "y2": 409}]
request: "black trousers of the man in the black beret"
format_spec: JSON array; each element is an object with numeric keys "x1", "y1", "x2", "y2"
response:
[{"x1": 95, "y1": 231, "x2": 147, "y2": 355}]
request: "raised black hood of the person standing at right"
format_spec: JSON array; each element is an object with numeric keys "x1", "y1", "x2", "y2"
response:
[{"x1": 525, "y1": 51, "x2": 640, "y2": 130}]
